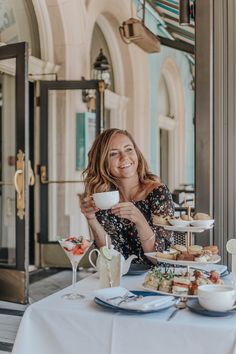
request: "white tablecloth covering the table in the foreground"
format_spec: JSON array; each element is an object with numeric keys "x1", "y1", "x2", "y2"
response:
[{"x1": 12, "y1": 274, "x2": 236, "y2": 354}]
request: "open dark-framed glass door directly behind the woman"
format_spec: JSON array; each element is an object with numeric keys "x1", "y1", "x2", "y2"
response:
[{"x1": 38, "y1": 80, "x2": 104, "y2": 267}]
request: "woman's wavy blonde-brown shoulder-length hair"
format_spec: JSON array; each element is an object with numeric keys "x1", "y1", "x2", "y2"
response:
[{"x1": 83, "y1": 128, "x2": 160, "y2": 195}]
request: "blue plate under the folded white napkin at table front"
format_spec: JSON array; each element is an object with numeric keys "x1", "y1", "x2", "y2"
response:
[{"x1": 94, "y1": 290, "x2": 173, "y2": 314}]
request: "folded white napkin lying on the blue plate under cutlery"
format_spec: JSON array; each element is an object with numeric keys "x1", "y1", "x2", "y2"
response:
[{"x1": 94, "y1": 287, "x2": 175, "y2": 312}]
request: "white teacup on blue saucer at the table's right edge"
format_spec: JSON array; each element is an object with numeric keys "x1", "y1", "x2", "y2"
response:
[{"x1": 198, "y1": 284, "x2": 236, "y2": 312}]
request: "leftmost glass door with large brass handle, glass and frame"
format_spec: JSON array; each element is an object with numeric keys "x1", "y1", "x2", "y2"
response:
[{"x1": 0, "y1": 43, "x2": 29, "y2": 303}]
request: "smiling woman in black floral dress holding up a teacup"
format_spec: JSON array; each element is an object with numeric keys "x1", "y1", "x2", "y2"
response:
[{"x1": 81, "y1": 129, "x2": 174, "y2": 264}]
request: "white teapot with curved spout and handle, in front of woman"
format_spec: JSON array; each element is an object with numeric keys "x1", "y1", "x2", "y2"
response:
[{"x1": 89, "y1": 246, "x2": 138, "y2": 276}]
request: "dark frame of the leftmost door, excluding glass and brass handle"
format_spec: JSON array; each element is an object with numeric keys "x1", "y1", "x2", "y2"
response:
[{"x1": 0, "y1": 42, "x2": 29, "y2": 303}]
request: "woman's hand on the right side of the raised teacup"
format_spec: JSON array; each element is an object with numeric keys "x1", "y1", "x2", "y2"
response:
[{"x1": 111, "y1": 202, "x2": 144, "y2": 224}]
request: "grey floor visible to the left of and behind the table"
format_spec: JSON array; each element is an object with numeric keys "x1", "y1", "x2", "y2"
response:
[{"x1": 0, "y1": 270, "x2": 91, "y2": 354}]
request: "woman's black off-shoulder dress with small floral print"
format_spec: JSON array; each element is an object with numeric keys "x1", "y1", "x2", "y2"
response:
[{"x1": 96, "y1": 184, "x2": 174, "y2": 264}]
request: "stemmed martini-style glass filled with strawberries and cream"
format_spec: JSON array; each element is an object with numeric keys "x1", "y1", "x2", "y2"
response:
[{"x1": 58, "y1": 236, "x2": 92, "y2": 300}]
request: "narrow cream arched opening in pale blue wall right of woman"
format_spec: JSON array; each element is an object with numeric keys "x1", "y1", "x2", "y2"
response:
[{"x1": 157, "y1": 58, "x2": 185, "y2": 190}]
